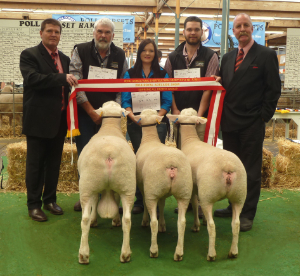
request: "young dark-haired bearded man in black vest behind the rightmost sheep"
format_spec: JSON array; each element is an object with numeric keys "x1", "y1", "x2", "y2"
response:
[{"x1": 165, "y1": 16, "x2": 219, "y2": 217}]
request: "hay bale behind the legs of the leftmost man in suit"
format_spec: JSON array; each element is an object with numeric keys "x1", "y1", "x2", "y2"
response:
[{"x1": 6, "y1": 141, "x2": 78, "y2": 193}]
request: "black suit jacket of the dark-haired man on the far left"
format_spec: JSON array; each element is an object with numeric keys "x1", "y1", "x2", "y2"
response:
[{"x1": 20, "y1": 42, "x2": 70, "y2": 138}]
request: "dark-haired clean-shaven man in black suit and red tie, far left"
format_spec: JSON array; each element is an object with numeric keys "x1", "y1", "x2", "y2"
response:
[{"x1": 20, "y1": 18, "x2": 77, "y2": 221}]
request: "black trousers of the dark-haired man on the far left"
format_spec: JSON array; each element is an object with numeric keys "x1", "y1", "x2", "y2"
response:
[{"x1": 26, "y1": 111, "x2": 67, "y2": 210}]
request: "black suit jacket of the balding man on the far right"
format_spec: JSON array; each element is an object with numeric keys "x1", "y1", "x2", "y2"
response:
[{"x1": 220, "y1": 42, "x2": 281, "y2": 132}]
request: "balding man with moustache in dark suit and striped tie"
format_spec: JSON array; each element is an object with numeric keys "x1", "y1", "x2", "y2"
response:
[{"x1": 214, "y1": 13, "x2": 281, "y2": 231}]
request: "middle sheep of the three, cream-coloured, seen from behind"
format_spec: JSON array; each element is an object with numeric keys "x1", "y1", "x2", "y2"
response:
[{"x1": 135, "y1": 109, "x2": 193, "y2": 261}]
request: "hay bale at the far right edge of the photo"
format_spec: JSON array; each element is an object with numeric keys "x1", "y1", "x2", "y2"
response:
[{"x1": 273, "y1": 139, "x2": 300, "y2": 188}]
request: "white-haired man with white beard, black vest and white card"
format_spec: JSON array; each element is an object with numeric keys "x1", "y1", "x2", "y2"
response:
[{"x1": 70, "y1": 18, "x2": 128, "y2": 211}]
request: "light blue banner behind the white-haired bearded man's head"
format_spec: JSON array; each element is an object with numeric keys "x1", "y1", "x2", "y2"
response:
[{"x1": 52, "y1": 14, "x2": 135, "y2": 43}]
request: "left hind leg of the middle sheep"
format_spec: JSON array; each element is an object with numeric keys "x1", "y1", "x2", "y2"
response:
[{"x1": 146, "y1": 200, "x2": 158, "y2": 258}]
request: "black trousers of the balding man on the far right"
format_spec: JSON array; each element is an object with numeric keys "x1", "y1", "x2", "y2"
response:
[{"x1": 222, "y1": 118, "x2": 265, "y2": 220}]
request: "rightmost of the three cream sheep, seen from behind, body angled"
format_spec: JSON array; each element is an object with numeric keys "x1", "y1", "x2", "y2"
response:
[{"x1": 167, "y1": 108, "x2": 247, "y2": 261}]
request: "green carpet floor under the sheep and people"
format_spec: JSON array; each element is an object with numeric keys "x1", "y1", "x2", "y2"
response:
[{"x1": 0, "y1": 190, "x2": 300, "y2": 276}]
